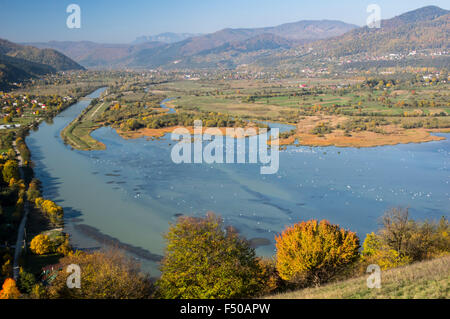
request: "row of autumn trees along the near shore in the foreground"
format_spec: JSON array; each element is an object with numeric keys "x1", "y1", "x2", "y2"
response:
[{"x1": 0, "y1": 208, "x2": 450, "y2": 299}]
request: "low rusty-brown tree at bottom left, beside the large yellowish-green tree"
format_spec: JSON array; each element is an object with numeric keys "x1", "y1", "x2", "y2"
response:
[{"x1": 48, "y1": 250, "x2": 152, "y2": 299}]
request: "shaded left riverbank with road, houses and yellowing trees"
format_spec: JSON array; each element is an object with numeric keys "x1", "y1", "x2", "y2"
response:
[{"x1": 0, "y1": 89, "x2": 109, "y2": 281}]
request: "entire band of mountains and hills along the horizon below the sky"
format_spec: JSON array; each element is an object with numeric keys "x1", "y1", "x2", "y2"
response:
[{"x1": 0, "y1": 6, "x2": 450, "y2": 85}]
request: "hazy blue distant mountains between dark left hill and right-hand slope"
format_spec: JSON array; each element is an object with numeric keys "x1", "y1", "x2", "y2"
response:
[{"x1": 28, "y1": 20, "x2": 357, "y2": 68}]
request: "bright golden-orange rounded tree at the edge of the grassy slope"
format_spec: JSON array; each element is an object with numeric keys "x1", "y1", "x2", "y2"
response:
[{"x1": 275, "y1": 220, "x2": 359, "y2": 286}]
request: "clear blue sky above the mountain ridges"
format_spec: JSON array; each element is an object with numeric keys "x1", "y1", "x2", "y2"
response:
[{"x1": 0, "y1": 0, "x2": 450, "y2": 43}]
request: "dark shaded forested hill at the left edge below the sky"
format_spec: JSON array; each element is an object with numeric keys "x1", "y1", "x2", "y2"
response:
[{"x1": 0, "y1": 39, "x2": 84, "y2": 90}]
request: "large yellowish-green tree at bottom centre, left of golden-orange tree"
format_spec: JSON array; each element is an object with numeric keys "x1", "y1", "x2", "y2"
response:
[{"x1": 157, "y1": 213, "x2": 262, "y2": 299}]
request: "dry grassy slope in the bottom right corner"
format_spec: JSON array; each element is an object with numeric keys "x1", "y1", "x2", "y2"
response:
[{"x1": 269, "y1": 256, "x2": 450, "y2": 299}]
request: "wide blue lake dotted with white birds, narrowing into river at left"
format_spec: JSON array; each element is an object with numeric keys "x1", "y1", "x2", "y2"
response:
[{"x1": 27, "y1": 90, "x2": 450, "y2": 274}]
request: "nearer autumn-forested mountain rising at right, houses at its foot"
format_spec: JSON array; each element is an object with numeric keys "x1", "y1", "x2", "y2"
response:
[{"x1": 262, "y1": 6, "x2": 450, "y2": 69}]
